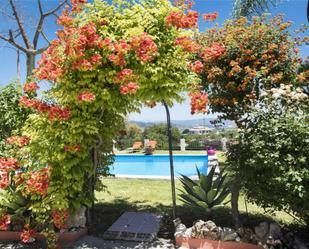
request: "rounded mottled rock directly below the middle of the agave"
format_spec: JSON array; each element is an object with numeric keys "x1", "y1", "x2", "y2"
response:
[{"x1": 191, "y1": 220, "x2": 220, "y2": 240}]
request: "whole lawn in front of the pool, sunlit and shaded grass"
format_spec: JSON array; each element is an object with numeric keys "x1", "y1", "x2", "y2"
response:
[{"x1": 91, "y1": 178, "x2": 308, "y2": 238}]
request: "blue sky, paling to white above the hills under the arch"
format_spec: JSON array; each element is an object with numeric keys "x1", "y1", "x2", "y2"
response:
[{"x1": 0, "y1": 0, "x2": 309, "y2": 121}]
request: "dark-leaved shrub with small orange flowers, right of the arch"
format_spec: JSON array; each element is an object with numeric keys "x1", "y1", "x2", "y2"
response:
[{"x1": 192, "y1": 15, "x2": 308, "y2": 123}]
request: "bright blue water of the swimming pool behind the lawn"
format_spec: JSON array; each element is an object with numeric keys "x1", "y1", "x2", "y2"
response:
[{"x1": 110, "y1": 155, "x2": 208, "y2": 176}]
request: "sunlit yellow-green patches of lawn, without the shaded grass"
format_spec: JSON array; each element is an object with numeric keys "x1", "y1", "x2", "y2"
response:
[{"x1": 97, "y1": 178, "x2": 293, "y2": 223}]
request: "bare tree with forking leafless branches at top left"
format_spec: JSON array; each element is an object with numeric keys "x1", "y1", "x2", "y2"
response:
[{"x1": 0, "y1": 0, "x2": 68, "y2": 77}]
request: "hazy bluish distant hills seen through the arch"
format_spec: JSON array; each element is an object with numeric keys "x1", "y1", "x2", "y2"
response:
[{"x1": 129, "y1": 118, "x2": 236, "y2": 130}]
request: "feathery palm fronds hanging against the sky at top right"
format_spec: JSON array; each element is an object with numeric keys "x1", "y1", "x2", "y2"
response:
[{"x1": 233, "y1": 0, "x2": 309, "y2": 22}]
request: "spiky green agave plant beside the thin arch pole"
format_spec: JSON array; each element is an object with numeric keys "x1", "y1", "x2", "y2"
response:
[{"x1": 179, "y1": 167, "x2": 230, "y2": 212}]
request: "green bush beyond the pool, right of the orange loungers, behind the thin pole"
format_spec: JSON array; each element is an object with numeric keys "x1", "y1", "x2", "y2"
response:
[{"x1": 143, "y1": 124, "x2": 181, "y2": 150}]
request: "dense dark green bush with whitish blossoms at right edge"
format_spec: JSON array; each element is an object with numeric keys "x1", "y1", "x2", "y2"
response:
[{"x1": 228, "y1": 87, "x2": 309, "y2": 225}]
